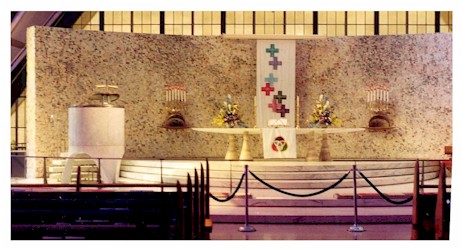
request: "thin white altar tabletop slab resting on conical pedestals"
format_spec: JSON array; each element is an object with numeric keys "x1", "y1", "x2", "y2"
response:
[{"x1": 191, "y1": 128, "x2": 366, "y2": 134}]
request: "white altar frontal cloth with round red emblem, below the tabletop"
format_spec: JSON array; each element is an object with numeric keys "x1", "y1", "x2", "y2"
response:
[{"x1": 262, "y1": 128, "x2": 297, "y2": 159}]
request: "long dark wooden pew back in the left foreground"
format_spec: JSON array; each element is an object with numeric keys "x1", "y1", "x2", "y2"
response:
[{"x1": 11, "y1": 191, "x2": 181, "y2": 240}]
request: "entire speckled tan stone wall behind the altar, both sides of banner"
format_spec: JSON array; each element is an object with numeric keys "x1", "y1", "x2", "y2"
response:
[{"x1": 27, "y1": 27, "x2": 452, "y2": 175}]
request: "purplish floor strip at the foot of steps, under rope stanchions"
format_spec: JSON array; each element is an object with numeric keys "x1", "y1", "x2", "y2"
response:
[{"x1": 210, "y1": 223, "x2": 411, "y2": 240}]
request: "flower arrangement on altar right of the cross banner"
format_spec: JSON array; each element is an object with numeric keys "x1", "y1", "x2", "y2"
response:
[{"x1": 307, "y1": 94, "x2": 341, "y2": 128}]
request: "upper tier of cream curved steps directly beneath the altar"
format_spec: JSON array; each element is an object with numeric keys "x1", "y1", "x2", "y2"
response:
[{"x1": 115, "y1": 160, "x2": 439, "y2": 192}]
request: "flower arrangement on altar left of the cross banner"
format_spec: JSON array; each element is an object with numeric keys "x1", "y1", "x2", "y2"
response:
[{"x1": 212, "y1": 94, "x2": 248, "y2": 128}]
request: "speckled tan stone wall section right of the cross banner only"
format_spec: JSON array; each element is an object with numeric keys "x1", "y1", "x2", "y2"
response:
[{"x1": 297, "y1": 34, "x2": 452, "y2": 158}]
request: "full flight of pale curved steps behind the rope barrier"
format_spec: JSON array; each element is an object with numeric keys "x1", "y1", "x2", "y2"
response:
[{"x1": 113, "y1": 160, "x2": 439, "y2": 225}]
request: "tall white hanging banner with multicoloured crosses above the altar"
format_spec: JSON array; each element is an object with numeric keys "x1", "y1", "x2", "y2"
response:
[{"x1": 256, "y1": 40, "x2": 296, "y2": 128}]
